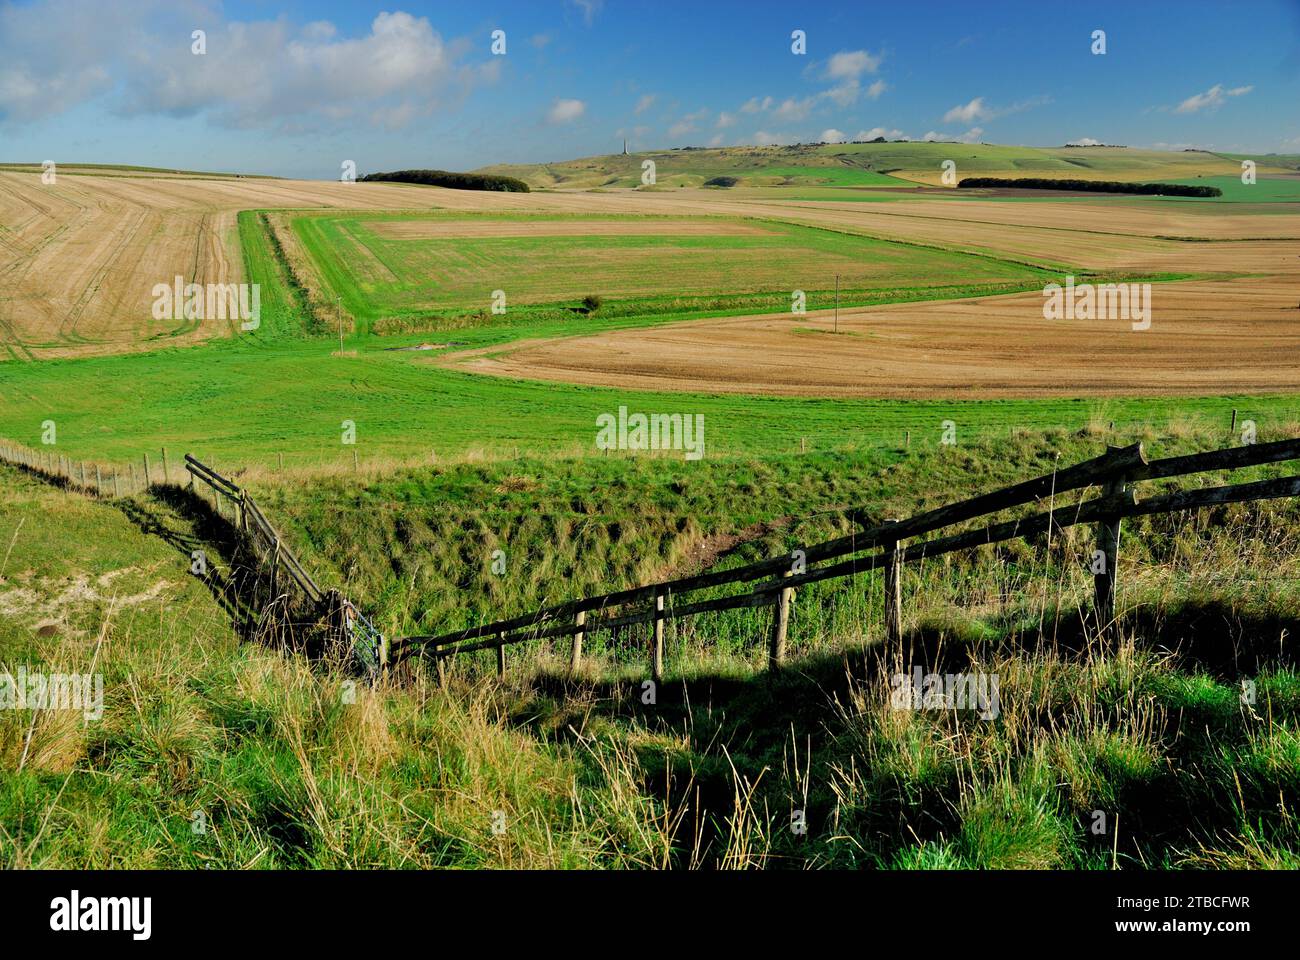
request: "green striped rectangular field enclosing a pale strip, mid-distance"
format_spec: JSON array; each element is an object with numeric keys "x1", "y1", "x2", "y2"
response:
[{"x1": 287, "y1": 208, "x2": 1066, "y2": 329}]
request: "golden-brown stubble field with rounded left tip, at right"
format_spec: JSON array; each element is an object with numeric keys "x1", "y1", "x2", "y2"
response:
[{"x1": 438, "y1": 270, "x2": 1300, "y2": 399}]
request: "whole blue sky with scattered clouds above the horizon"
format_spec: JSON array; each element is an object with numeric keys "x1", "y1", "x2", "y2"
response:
[{"x1": 0, "y1": 0, "x2": 1300, "y2": 178}]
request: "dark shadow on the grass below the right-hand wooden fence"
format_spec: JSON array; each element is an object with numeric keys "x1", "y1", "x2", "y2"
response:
[{"x1": 510, "y1": 602, "x2": 1300, "y2": 868}]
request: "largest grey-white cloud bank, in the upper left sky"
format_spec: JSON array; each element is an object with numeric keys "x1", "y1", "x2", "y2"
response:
[{"x1": 0, "y1": 0, "x2": 501, "y2": 130}]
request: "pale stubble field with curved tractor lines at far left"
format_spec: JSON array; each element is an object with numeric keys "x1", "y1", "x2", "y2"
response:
[{"x1": 0, "y1": 170, "x2": 447, "y2": 359}]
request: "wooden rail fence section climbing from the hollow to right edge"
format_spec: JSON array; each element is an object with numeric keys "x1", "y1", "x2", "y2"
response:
[{"x1": 391, "y1": 440, "x2": 1300, "y2": 679}]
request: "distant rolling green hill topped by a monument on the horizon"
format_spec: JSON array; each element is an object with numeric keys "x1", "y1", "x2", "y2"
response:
[{"x1": 477, "y1": 142, "x2": 1296, "y2": 190}]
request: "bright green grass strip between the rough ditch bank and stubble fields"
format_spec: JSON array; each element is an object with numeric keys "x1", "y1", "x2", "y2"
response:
[{"x1": 0, "y1": 330, "x2": 1300, "y2": 467}]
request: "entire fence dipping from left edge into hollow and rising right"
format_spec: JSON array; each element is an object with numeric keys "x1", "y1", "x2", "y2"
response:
[{"x1": 0, "y1": 438, "x2": 1300, "y2": 679}]
